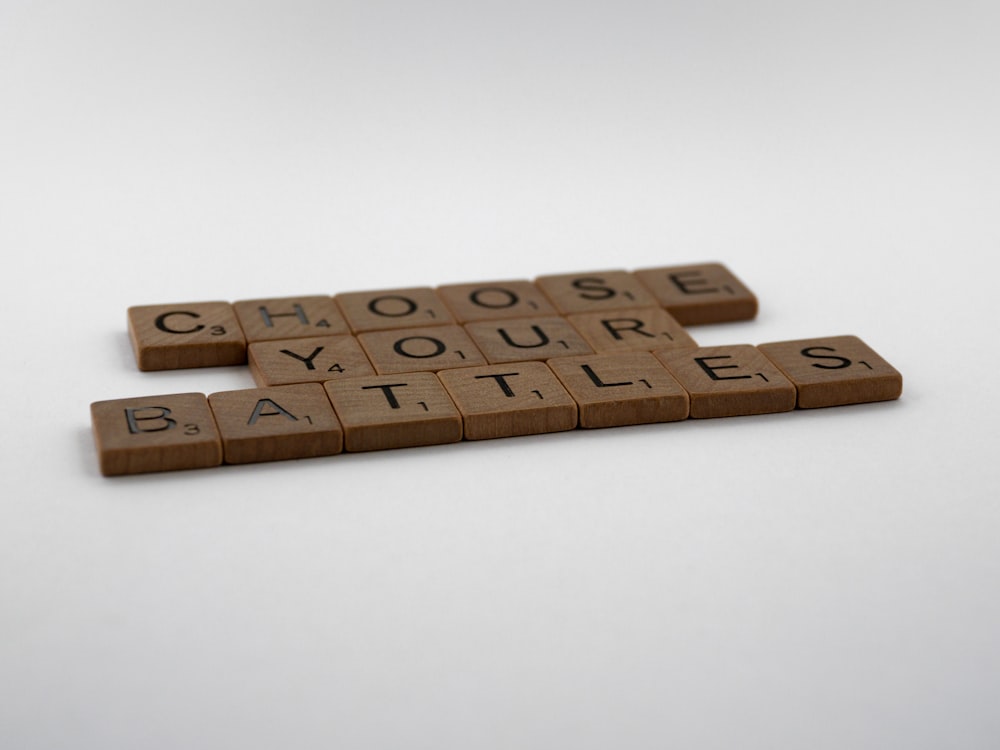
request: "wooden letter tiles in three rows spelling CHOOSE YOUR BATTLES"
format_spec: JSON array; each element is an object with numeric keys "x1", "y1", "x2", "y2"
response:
[{"x1": 91, "y1": 263, "x2": 902, "y2": 476}]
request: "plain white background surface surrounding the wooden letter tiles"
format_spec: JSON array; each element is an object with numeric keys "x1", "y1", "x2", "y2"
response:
[{"x1": 0, "y1": 0, "x2": 1000, "y2": 750}]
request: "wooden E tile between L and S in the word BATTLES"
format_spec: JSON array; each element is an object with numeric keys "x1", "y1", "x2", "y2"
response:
[{"x1": 654, "y1": 344, "x2": 795, "y2": 419}]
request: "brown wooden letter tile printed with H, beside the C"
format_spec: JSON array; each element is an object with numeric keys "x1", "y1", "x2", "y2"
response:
[{"x1": 233, "y1": 296, "x2": 350, "y2": 342}]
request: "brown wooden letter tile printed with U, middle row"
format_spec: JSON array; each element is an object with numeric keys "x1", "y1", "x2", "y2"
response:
[{"x1": 465, "y1": 316, "x2": 593, "y2": 364}]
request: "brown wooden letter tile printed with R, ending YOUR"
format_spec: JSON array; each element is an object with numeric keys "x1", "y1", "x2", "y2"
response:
[{"x1": 566, "y1": 307, "x2": 698, "y2": 352}]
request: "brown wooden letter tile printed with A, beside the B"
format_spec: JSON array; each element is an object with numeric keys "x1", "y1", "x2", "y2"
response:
[{"x1": 208, "y1": 383, "x2": 344, "y2": 464}]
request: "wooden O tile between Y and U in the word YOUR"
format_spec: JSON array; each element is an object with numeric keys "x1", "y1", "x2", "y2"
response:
[{"x1": 358, "y1": 325, "x2": 486, "y2": 375}]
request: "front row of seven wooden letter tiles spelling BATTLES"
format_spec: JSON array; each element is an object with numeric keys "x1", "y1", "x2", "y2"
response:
[{"x1": 91, "y1": 336, "x2": 902, "y2": 476}]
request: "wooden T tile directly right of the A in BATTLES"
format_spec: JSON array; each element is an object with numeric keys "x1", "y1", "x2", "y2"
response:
[{"x1": 326, "y1": 372, "x2": 462, "y2": 451}]
